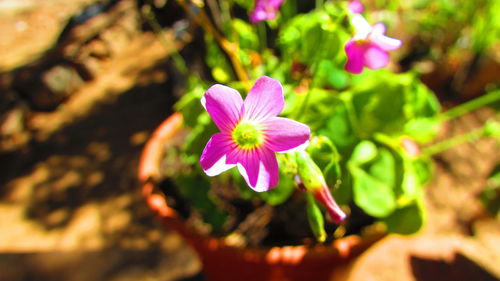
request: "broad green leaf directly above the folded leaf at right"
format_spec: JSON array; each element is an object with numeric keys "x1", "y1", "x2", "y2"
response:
[{"x1": 351, "y1": 70, "x2": 439, "y2": 138}]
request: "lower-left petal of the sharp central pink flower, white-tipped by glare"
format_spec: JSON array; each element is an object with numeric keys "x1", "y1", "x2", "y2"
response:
[{"x1": 200, "y1": 133, "x2": 236, "y2": 177}]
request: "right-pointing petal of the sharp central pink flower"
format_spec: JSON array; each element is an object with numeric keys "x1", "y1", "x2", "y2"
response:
[{"x1": 262, "y1": 117, "x2": 311, "y2": 152}]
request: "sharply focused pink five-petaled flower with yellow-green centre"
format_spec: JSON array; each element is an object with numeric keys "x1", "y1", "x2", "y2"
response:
[{"x1": 200, "y1": 76, "x2": 310, "y2": 192}]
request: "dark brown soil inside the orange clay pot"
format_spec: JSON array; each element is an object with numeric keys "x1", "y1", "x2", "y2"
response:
[{"x1": 159, "y1": 162, "x2": 373, "y2": 247}]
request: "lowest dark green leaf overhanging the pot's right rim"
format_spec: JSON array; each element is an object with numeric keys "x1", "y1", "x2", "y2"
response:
[{"x1": 383, "y1": 201, "x2": 425, "y2": 234}]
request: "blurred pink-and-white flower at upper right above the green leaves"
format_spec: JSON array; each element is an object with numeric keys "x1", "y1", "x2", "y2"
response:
[{"x1": 345, "y1": 14, "x2": 401, "y2": 74}]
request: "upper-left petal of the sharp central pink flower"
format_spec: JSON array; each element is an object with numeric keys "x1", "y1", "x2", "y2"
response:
[{"x1": 201, "y1": 84, "x2": 243, "y2": 131}]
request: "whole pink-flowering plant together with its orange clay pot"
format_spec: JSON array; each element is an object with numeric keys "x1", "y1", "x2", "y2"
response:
[{"x1": 139, "y1": 1, "x2": 500, "y2": 280}]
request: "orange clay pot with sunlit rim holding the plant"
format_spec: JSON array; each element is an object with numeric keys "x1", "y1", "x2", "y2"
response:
[{"x1": 139, "y1": 113, "x2": 383, "y2": 281}]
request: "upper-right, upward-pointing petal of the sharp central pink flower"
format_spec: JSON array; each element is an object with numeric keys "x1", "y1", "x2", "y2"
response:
[{"x1": 244, "y1": 76, "x2": 285, "y2": 121}]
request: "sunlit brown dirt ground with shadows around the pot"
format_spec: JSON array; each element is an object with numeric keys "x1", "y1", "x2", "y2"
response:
[{"x1": 0, "y1": 0, "x2": 500, "y2": 281}]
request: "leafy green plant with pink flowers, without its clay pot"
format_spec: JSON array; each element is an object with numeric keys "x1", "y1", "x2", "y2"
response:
[{"x1": 168, "y1": 0, "x2": 460, "y2": 242}]
